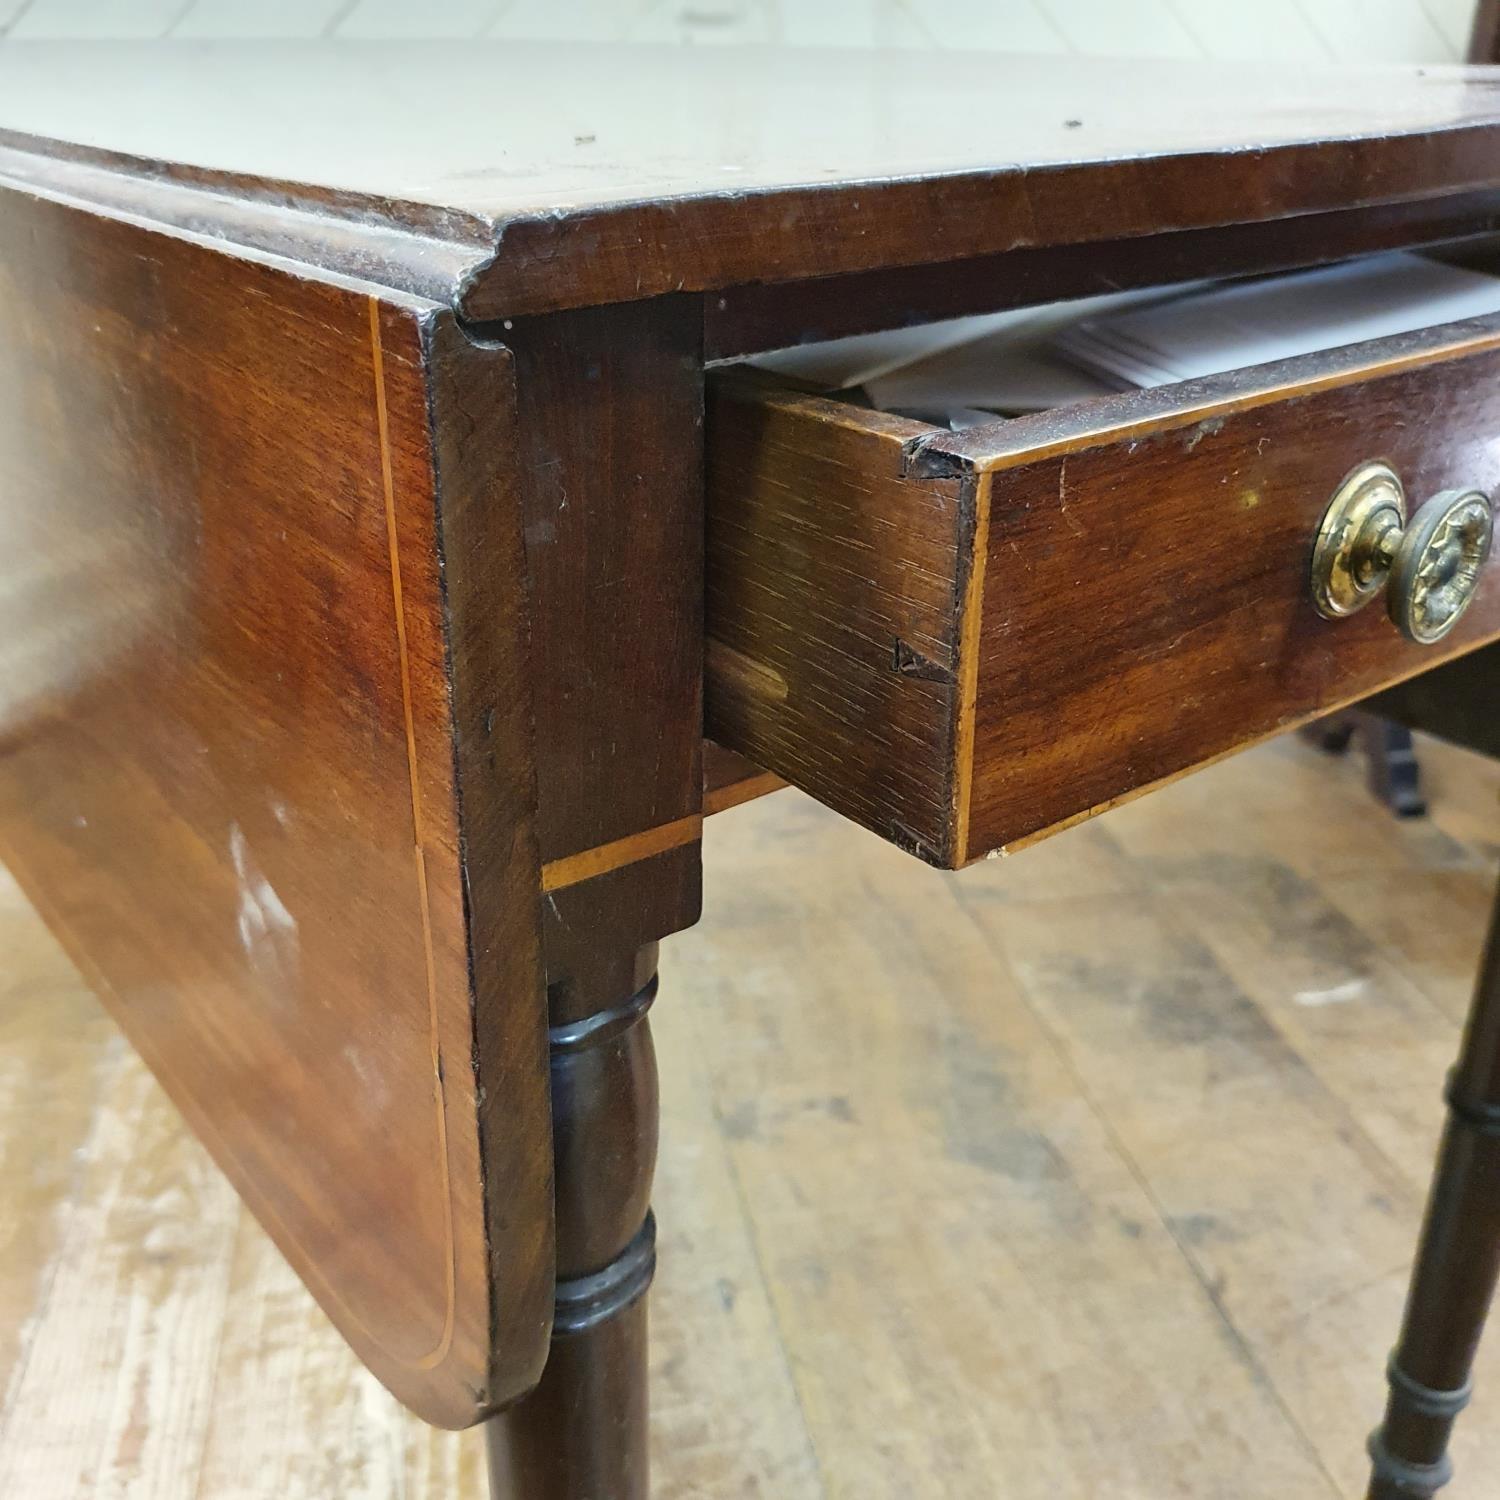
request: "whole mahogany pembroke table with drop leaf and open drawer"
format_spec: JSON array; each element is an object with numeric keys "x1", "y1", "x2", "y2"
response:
[{"x1": 0, "y1": 44, "x2": 1500, "y2": 1500}]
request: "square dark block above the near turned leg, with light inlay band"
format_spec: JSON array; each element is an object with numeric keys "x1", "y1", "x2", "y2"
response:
[{"x1": 491, "y1": 297, "x2": 704, "y2": 1005}]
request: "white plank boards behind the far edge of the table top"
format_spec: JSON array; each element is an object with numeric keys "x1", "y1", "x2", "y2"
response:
[{"x1": 0, "y1": 0, "x2": 1473, "y2": 63}]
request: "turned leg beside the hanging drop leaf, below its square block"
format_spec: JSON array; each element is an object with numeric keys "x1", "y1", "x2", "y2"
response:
[{"x1": 489, "y1": 948, "x2": 657, "y2": 1500}]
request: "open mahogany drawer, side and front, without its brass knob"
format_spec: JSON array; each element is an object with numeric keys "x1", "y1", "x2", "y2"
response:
[{"x1": 707, "y1": 317, "x2": 1500, "y2": 867}]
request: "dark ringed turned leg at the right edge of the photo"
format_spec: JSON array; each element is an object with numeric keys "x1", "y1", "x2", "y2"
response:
[{"x1": 1370, "y1": 899, "x2": 1500, "y2": 1500}]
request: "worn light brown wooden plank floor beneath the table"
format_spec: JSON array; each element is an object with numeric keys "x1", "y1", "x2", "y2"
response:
[{"x1": 0, "y1": 740, "x2": 1500, "y2": 1500}]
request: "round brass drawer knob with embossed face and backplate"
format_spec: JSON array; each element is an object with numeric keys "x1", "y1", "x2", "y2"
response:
[{"x1": 1313, "y1": 464, "x2": 1494, "y2": 645}]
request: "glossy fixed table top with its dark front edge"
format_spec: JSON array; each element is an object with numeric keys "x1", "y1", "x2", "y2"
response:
[{"x1": 0, "y1": 42, "x2": 1500, "y2": 318}]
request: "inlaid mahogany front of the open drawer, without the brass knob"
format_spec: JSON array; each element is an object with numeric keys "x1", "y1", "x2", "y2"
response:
[{"x1": 960, "y1": 326, "x2": 1500, "y2": 860}]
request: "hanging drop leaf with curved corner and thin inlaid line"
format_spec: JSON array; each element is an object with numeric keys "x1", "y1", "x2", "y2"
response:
[{"x1": 0, "y1": 178, "x2": 552, "y2": 1425}]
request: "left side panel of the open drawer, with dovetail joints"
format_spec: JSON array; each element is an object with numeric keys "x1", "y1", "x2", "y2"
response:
[{"x1": 705, "y1": 378, "x2": 963, "y2": 849}]
